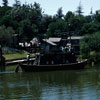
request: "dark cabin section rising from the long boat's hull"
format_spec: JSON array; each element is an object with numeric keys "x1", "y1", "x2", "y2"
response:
[{"x1": 35, "y1": 52, "x2": 76, "y2": 65}]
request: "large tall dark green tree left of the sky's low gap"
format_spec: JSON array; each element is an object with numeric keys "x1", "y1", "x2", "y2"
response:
[{"x1": 9, "y1": 0, "x2": 42, "y2": 41}]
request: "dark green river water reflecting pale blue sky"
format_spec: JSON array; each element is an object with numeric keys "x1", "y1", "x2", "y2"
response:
[{"x1": 0, "y1": 67, "x2": 100, "y2": 100}]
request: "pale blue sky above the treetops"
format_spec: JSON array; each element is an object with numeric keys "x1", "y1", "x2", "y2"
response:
[{"x1": 0, "y1": 0, "x2": 100, "y2": 15}]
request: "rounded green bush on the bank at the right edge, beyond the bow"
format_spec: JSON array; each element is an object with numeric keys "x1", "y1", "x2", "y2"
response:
[{"x1": 80, "y1": 32, "x2": 100, "y2": 63}]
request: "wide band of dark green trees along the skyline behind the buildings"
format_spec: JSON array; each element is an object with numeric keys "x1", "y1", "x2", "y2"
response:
[{"x1": 0, "y1": 0, "x2": 100, "y2": 44}]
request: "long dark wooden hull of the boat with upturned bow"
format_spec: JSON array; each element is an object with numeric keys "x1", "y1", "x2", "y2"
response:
[{"x1": 20, "y1": 60, "x2": 87, "y2": 72}]
